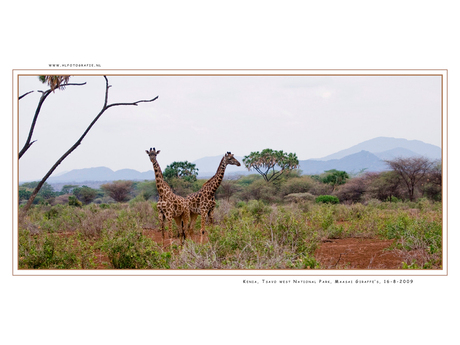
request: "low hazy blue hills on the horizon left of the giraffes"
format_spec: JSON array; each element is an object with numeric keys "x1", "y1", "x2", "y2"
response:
[{"x1": 47, "y1": 167, "x2": 155, "y2": 183}]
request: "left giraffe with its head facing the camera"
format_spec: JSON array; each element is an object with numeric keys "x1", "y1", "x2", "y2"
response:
[{"x1": 145, "y1": 148, "x2": 190, "y2": 244}]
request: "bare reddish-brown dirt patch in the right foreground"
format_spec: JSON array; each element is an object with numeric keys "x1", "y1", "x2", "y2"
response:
[{"x1": 315, "y1": 238, "x2": 404, "y2": 269}]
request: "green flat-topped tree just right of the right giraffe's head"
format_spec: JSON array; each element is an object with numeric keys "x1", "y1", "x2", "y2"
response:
[{"x1": 243, "y1": 149, "x2": 299, "y2": 182}]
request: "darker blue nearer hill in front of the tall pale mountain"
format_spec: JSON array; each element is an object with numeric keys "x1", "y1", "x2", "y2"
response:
[{"x1": 299, "y1": 150, "x2": 388, "y2": 175}]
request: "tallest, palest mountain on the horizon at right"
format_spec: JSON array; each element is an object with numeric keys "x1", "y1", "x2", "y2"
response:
[{"x1": 317, "y1": 137, "x2": 441, "y2": 161}]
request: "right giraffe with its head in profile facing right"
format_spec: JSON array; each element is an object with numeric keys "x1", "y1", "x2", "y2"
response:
[{"x1": 185, "y1": 152, "x2": 241, "y2": 243}]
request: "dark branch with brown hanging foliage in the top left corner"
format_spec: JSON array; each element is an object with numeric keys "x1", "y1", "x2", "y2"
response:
[{"x1": 19, "y1": 75, "x2": 86, "y2": 159}]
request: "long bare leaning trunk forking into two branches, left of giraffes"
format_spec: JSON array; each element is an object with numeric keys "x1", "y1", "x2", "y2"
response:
[{"x1": 22, "y1": 76, "x2": 158, "y2": 213}]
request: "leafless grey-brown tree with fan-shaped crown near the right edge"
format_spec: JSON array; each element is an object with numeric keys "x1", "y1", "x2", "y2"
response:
[{"x1": 385, "y1": 157, "x2": 433, "y2": 201}]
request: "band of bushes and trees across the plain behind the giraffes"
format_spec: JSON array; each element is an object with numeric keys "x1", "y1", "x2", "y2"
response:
[{"x1": 19, "y1": 158, "x2": 442, "y2": 206}]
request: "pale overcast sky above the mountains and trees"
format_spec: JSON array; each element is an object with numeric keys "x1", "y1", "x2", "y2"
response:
[{"x1": 19, "y1": 75, "x2": 441, "y2": 181}]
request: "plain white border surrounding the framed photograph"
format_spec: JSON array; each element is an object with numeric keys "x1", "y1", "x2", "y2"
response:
[{"x1": 0, "y1": 1, "x2": 460, "y2": 344}]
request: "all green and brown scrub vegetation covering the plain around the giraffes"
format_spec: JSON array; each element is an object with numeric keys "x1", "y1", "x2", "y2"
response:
[{"x1": 19, "y1": 156, "x2": 443, "y2": 269}]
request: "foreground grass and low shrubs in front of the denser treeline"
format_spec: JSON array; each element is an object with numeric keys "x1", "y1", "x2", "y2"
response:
[{"x1": 19, "y1": 200, "x2": 442, "y2": 269}]
